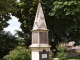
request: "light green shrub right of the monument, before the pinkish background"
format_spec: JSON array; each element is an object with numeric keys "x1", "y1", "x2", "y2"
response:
[{"x1": 57, "y1": 45, "x2": 67, "y2": 60}]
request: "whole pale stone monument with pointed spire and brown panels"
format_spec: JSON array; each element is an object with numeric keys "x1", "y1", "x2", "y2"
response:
[{"x1": 29, "y1": 3, "x2": 50, "y2": 60}]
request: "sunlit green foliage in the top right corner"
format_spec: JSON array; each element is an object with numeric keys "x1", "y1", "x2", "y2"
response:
[{"x1": 51, "y1": 0, "x2": 80, "y2": 17}]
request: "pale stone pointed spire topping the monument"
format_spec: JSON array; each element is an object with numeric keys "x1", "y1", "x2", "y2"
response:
[{"x1": 32, "y1": 3, "x2": 48, "y2": 30}]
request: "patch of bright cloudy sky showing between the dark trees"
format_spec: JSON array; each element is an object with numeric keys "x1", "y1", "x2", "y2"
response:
[{"x1": 4, "y1": 16, "x2": 21, "y2": 35}]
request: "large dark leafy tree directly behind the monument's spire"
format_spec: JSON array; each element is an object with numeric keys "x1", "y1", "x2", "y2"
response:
[{"x1": 16, "y1": 0, "x2": 80, "y2": 47}]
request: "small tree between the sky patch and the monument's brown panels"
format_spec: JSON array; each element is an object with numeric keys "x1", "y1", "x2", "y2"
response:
[{"x1": 15, "y1": 30, "x2": 30, "y2": 48}]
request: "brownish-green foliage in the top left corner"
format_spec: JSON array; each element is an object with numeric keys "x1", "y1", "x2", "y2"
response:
[{"x1": 0, "y1": 0, "x2": 17, "y2": 14}]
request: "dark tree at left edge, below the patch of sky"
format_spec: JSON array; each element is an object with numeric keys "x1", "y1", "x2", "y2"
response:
[{"x1": 0, "y1": 31, "x2": 18, "y2": 58}]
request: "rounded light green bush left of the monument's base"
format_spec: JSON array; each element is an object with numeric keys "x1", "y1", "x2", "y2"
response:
[{"x1": 3, "y1": 46, "x2": 31, "y2": 60}]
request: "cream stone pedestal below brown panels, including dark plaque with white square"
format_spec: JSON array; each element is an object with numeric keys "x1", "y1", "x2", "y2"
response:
[{"x1": 30, "y1": 44, "x2": 50, "y2": 60}]
